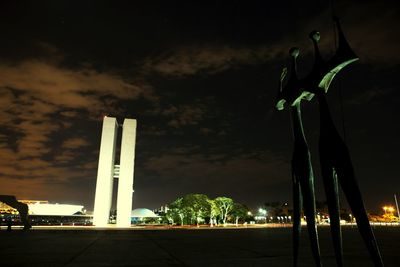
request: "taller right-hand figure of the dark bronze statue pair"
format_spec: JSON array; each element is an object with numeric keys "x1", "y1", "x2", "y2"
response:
[{"x1": 276, "y1": 18, "x2": 383, "y2": 266}]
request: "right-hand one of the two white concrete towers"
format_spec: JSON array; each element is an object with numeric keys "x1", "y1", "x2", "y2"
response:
[{"x1": 117, "y1": 119, "x2": 136, "y2": 227}]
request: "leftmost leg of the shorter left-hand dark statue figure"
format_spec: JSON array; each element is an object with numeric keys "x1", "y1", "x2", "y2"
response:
[{"x1": 293, "y1": 177, "x2": 302, "y2": 267}]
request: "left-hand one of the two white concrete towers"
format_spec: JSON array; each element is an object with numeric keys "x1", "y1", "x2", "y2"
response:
[{"x1": 93, "y1": 117, "x2": 118, "y2": 227}]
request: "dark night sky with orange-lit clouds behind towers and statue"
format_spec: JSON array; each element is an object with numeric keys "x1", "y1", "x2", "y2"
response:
[{"x1": 0, "y1": 0, "x2": 400, "y2": 214}]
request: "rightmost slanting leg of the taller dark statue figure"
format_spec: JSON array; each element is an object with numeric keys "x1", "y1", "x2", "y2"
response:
[{"x1": 336, "y1": 150, "x2": 383, "y2": 266}]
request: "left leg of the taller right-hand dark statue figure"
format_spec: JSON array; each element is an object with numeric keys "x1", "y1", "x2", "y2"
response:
[{"x1": 321, "y1": 157, "x2": 343, "y2": 267}]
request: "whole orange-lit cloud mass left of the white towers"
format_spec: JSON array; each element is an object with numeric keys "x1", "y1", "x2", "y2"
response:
[{"x1": 0, "y1": 60, "x2": 152, "y2": 193}]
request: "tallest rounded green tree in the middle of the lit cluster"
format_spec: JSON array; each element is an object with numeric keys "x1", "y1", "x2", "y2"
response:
[{"x1": 182, "y1": 194, "x2": 210, "y2": 225}]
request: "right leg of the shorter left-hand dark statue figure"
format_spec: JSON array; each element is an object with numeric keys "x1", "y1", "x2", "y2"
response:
[{"x1": 300, "y1": 171, "x2": 322, "y2": 266}]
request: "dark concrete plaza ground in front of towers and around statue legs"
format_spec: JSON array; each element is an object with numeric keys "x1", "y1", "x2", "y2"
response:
[{"x1": 0, "y1": 227, "x2": 400, "y2": 267}]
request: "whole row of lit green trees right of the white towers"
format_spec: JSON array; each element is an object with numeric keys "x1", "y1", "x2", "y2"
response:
[{"x1": 165, "y1": 194, "x2": 250, "y2": 226}]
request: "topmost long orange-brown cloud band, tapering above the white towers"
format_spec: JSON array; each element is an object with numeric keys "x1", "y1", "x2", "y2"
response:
[{"x1": 0, "y1": 61, "x2": 143, "y2": 112}]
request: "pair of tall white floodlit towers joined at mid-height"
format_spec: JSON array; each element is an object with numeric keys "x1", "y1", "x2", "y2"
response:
[{"x1": 93, "y1": 116, "x2": 136, "y2": 227}]
